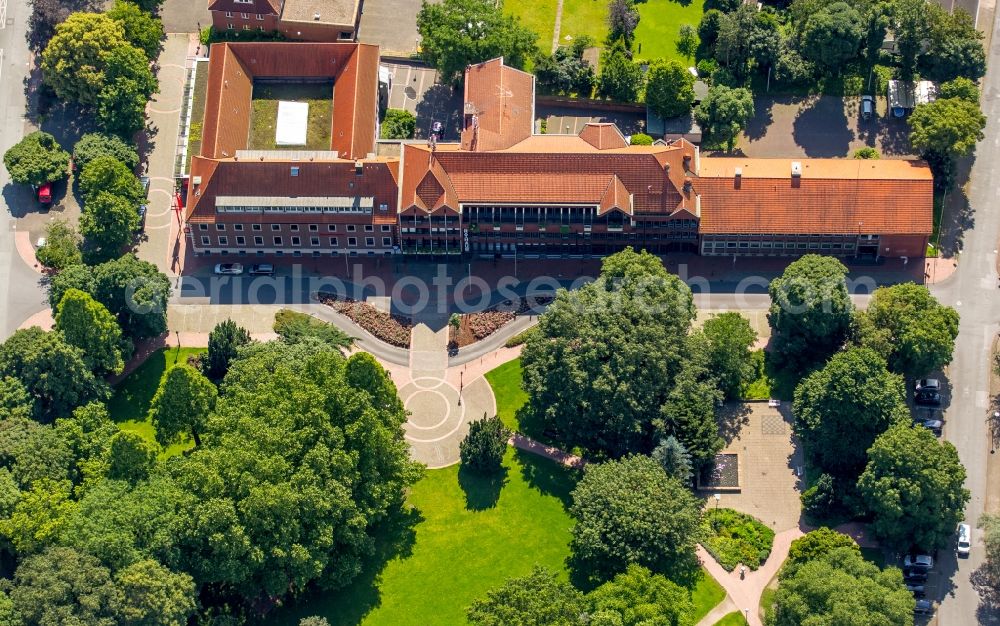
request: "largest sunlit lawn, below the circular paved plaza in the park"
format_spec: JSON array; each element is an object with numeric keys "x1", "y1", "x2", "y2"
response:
[{"x1": 268, "y1": 449, "x2": 576, "y2": 626}]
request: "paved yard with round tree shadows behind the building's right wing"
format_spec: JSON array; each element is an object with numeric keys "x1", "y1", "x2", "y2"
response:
[{"x1": 737, "y1": 96, "x2": 912, "y2": 158}]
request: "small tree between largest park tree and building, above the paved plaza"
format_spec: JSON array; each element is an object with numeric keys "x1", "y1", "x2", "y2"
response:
[{"x1": 702, "y1": 312, "x2": 757, "y2": 400}]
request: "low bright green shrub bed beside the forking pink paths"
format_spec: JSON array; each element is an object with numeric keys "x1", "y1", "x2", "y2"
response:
[{"x1": 702, "y1": 509, "x2": 774, "y2": 572}]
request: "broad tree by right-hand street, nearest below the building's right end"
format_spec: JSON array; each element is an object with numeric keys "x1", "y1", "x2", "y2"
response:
[{"x1": 859, "y1": 283, "x2": 958, "y2": 378}]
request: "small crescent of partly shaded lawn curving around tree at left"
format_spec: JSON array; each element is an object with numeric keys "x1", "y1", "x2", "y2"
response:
[{"x1": 108, "y1": 348, "x2": 205, "y2": 456}]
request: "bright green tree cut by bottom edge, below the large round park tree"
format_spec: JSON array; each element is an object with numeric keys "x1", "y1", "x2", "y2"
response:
[{"x1": 587, "y1": 565, "x2": 695, "y2": 626}]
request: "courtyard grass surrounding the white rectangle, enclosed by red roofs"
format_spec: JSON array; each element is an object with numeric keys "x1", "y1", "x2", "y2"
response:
[{"x1": 247, "y1": 84, "x2": 333, "y2": 150}]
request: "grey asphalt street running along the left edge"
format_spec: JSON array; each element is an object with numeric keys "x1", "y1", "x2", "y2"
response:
[{"x1": 0, "y1": 0, "x2": 45, "y2": 338}]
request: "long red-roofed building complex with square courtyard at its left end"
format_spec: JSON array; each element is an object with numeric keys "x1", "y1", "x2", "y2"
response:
[{"x1": 187, "y1": 43, "x2": 933, "y2": 258}]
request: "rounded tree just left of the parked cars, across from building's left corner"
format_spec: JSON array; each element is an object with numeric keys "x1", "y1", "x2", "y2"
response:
[{"x1": 92, "y1": 254, "x2": 170, "y2": 339}]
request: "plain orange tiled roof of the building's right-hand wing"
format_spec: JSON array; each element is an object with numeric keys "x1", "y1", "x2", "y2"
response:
[{"x1": 693, "y1": 158, "x2": 933, "y2": 235}]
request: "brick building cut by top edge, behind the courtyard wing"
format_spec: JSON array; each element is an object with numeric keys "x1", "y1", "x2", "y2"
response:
[{"x1": 208, "y1": 0, "x2": 361, "y2": 42}]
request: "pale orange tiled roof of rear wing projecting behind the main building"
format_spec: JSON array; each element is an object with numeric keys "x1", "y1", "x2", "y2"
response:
[{"x1": 462, "y1": 58, "x2": 535, "y2": 152}]
